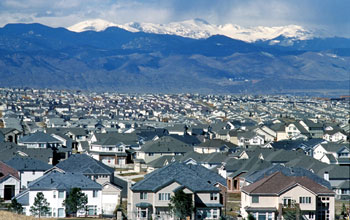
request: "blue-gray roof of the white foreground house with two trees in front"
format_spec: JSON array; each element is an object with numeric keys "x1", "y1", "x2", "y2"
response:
[{"x1": 28, "y1": 171, "x2": 102, "y2": 191}]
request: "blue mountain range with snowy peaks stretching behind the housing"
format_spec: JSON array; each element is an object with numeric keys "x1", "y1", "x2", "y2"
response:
[{"x1": 0, "y1": 19, "x2": 350, "y2": 95}]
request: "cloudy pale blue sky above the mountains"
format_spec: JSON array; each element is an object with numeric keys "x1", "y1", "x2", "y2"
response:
[{"x1": 0, "y1": 0, "x2": 350, "y2": 37}]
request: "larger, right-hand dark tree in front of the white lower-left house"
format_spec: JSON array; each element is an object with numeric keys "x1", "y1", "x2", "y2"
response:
[{"x1": 63, "y1": 188, "x2": 88, "y2": 216}]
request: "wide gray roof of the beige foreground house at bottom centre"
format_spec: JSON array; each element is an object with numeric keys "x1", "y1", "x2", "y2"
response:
[{"x1": 131, "y1": 162, "x2": 226, "y2": 192}]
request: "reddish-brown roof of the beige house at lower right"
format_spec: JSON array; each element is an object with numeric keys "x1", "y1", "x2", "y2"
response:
[{"x1": 242, "y1": 172, "x2": 334, "y2": 196}]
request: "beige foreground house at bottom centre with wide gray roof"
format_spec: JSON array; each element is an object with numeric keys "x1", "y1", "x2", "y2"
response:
[{"x1": 128, "y1": 162, "x2": 226, "y2": 220}]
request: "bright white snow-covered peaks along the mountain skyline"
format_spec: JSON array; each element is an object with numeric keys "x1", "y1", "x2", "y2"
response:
[{"x1": 68, "y1": 19, "x2": 315, "y2": 44}]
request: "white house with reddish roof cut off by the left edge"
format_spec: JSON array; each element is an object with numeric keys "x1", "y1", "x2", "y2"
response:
[{"x1": 0, "y1": 161, "x2": 20, "y2": 201}]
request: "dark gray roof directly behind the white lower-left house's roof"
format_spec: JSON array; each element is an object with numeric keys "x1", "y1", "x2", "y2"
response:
[{"x1": 56, "y1": 154, "x2": 114, "y2": 175}]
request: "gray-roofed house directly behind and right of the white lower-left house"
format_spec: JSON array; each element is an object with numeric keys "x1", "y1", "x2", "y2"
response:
[{"x1": 54, "y1": 154, "x2": 122, "y2": 215}]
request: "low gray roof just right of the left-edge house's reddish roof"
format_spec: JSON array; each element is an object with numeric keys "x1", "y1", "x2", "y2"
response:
[{"x1": 5, "y1": 156, "x2": 52, "y2": 171}]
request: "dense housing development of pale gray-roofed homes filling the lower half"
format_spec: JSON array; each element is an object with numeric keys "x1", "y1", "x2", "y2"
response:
[{"x1": 0, "y1": 88, "x2": 350, "y2": 220}]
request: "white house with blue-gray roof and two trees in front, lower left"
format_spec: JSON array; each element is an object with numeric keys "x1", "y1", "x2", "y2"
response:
[{"x1": 15, "y1": 170, "x2": 102, "y2": 218}]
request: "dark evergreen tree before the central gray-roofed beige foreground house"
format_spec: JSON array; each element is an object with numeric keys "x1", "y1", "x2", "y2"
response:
[{"x1": 169, "y1": 190, "x2": 193, "y2": 219}]
